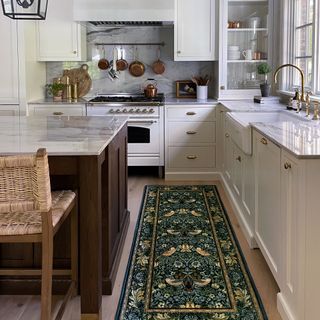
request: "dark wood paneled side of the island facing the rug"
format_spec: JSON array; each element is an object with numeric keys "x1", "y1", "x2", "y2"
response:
[{"x1": 102, "y1": 126, "x2": 129, "y2": 294}]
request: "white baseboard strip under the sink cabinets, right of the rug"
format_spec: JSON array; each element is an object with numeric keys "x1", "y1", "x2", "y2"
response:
[{"x1": 219, "y1": 173, "x2": 259, "y2": 249}]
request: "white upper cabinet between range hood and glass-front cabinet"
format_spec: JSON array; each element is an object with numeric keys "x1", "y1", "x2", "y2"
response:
[{"x1": 174, "y1": 0, "x2": 218, "y2": 61}]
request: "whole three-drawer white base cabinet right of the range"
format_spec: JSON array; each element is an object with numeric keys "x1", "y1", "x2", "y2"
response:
[{"x1": 165, "y1": 105, "x2": 216, "y2": 180}]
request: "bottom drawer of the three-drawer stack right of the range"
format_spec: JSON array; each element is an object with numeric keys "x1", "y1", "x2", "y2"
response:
[{"x1": 168, "y1": 147, "x2": 216, "y2": 168}]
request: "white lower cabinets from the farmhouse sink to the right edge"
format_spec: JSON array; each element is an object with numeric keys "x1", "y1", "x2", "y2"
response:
[{"x1": 254, "y1": 131, "x2": 320, "y2": 320}]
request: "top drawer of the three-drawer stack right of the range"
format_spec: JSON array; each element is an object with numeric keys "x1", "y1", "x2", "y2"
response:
[{"x1": 167, "y1": 106, "x2": 216, "y2": 121}]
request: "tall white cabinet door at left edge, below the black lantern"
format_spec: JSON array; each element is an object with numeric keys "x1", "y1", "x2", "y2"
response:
[{"x1": 0, "y1": 14, "x2": 19, "y2": 104}]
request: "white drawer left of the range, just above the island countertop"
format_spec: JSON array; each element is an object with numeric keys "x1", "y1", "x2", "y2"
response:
[{"x1": 29, "y1": 105, "x2": 86, "y2": 116}]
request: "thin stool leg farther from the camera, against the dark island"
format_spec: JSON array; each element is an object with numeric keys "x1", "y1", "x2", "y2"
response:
[{"x1": 71, "y1": 198, "x2": 78, "y2": 295}]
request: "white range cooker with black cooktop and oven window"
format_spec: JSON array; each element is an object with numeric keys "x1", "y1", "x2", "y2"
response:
[{"x1": 86, "y1": 94, "x2": 164, "y2": 172}]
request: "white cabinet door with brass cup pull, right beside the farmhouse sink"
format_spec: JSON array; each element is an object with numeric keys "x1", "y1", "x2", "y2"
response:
[{"x1": 254, "y1": 132, "x2": 283, "y2": 283}]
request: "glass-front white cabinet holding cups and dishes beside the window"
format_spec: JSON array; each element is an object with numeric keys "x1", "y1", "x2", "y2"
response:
[{"x1": 219, "y1": 0, "x2": 272, "y2": 99}]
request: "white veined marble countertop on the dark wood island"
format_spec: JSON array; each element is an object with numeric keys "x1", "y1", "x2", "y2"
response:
[{"x1": 0, "y1": 116, "x2": 128, "y2": 156}]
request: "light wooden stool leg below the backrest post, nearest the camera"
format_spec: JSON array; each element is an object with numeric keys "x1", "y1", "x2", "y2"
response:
[{"x1": 41, "y1": 213, "x2": 53, "y2": 320}]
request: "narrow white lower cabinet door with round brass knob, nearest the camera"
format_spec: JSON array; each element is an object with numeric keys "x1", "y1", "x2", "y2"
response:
[{"x1": 279, "y1": 151, "x2": 305, "y2": 319}]
